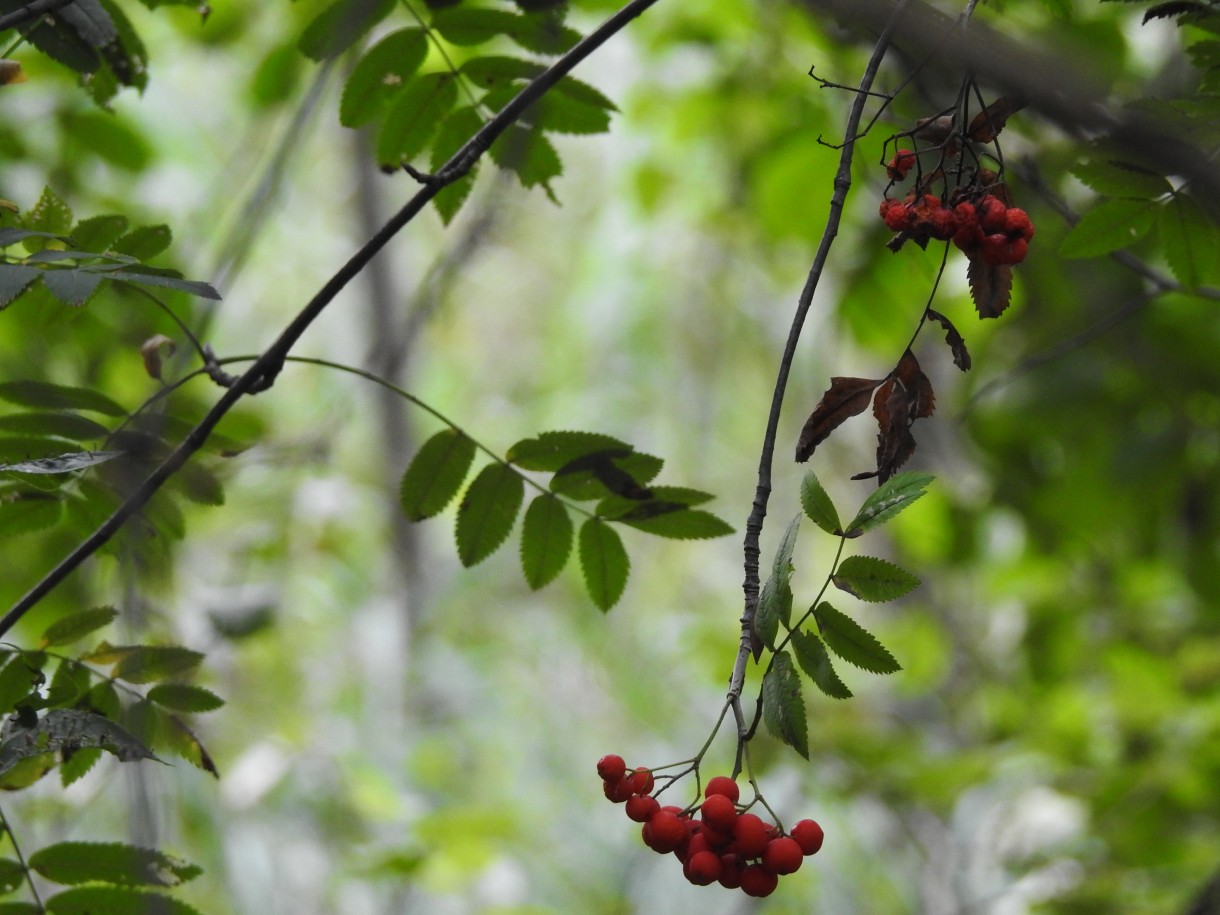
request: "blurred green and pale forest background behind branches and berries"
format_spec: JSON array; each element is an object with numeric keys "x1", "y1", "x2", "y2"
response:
[{"x1": 0, "y1": 0, "x2": 1220, "y2": 915}]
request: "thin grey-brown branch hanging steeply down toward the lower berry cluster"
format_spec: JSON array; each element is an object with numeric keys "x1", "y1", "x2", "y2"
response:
[{"x1": 727, "y1": 0, "x2": 910, "y2": 697}]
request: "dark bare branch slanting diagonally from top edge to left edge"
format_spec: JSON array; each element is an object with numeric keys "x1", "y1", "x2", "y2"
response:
[{"x1": 0, "y1": 0, "x2": 656, "y2": 636}]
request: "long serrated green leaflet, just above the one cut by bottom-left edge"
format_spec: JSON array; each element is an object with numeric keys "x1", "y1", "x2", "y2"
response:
[{"x1": 29, "y1": 842, "x2": 204, "y2": 887}]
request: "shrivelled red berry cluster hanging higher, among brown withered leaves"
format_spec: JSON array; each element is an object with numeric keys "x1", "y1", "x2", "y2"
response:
[{"x1": 880, "y1": 149, "x2": 1033, "y2": 267}]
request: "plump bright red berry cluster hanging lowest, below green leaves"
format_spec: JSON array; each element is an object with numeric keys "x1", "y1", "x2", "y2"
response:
[{"x1": 598, "y1": 754, "x2": 822, "y2": 897}]
